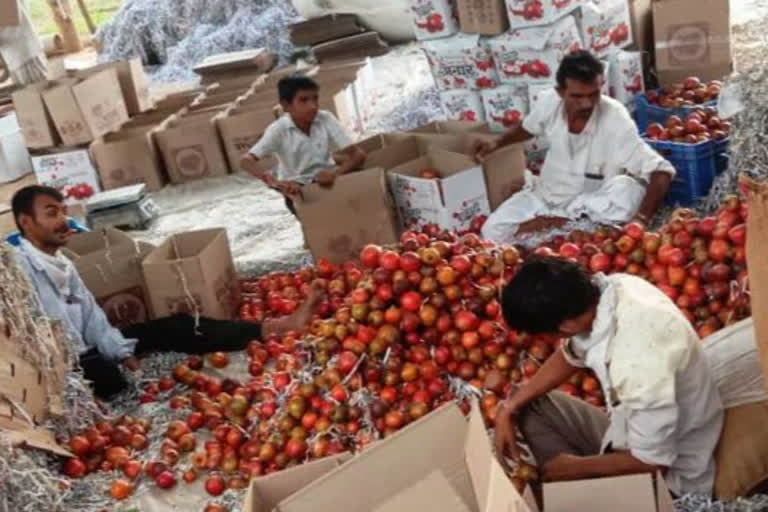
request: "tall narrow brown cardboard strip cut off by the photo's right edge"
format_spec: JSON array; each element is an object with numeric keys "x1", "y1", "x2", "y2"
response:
[{"x1": 743, "y1": 178, "x2": 768, "y2": 382}]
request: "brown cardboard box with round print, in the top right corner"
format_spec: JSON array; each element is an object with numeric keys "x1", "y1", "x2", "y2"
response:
[{"x1": 653, "y1": 0, "x2": 732, "y2": 85}]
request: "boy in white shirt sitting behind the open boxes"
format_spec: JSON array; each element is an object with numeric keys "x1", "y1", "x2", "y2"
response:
[{"x1": 242, "y1": 75, "x2": 366, "y2": 213}]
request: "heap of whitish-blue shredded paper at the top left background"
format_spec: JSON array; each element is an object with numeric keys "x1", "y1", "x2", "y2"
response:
[{"x1": 97, "y1": 0, "x2": 300, "y2": 82}]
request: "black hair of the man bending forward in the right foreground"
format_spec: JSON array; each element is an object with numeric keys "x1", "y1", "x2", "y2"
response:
[{"x1": 501, "y1": 258, "x2": 600, "y2": 334}]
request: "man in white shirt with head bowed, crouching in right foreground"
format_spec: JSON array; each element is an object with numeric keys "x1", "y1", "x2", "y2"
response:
[{"x1": 496, "y1": 258, "x2": 723, "y2": 495}]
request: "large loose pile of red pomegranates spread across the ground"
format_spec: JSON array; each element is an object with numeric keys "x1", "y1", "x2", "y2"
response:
[{"x1": 58, "y1": 197, "x2": 750, "y2": 510}]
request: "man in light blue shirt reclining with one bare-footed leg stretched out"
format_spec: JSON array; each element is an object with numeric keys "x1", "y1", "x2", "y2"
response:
[{"x1": 12, "y1": 185, "x2": 321, "y2": 399}]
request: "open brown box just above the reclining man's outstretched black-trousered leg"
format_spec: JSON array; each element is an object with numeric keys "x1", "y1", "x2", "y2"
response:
[{"x1": 142, "y1": 228, "x2": 240, "y2": 320}]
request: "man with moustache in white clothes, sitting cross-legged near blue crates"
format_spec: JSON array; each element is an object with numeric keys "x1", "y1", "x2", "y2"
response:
[{"x1": 475, "y1": 52, "x2": 675, "y2": 243}]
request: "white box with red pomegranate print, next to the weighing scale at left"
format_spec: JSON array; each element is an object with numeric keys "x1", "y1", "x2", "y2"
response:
[{"x1": 32, "y1": 148, "x2": 101, "y2": 205}]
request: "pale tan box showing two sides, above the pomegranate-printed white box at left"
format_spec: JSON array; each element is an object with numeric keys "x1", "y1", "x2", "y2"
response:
[{"x1": 43, "y1": 69, "x2": 128, "y2": 146}]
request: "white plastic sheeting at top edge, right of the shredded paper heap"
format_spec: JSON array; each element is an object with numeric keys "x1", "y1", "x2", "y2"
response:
[{"x1": 293, "y1": 0, "x2": 416, "y2": 42}]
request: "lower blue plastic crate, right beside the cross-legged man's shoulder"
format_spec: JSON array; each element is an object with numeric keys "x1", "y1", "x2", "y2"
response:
[{"x1": 646, "y1": 139, "x2": 717, "y2": 206}]
